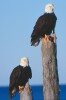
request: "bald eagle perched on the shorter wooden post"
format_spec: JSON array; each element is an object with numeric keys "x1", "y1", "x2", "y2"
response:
[{"x1": 9, "y1": 58, "x2": 32, "y2": 98}]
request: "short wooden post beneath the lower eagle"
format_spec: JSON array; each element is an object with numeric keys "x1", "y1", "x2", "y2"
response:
[{"x1": 20, "y1": 84, "x2": 33, "y2": 100}]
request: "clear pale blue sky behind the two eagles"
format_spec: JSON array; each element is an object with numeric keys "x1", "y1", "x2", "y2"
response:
[{"x1": 0, "y1": 0, "x2": 66, "y2": 86}]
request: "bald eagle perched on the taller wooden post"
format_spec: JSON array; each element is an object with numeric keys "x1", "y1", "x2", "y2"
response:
[{"x1": 31, "y1": 4, "x2": 57, "y2": 46}]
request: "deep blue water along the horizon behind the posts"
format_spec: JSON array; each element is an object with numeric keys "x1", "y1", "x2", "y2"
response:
[{"x1": 0, "y1": 85, "x2": 66, "y2": 100}]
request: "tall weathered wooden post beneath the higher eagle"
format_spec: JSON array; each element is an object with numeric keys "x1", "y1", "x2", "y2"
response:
[{"x1": 42, "y1": 37, "x2": 59, "y2": 100}]
